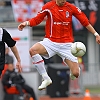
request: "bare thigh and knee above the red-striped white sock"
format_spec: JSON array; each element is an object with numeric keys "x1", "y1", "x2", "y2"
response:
[{"x1": 30, "y1": 43, "x2": 48, "y2": 55}]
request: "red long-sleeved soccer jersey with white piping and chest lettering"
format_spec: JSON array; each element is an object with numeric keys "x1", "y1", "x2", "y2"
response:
[{"x1": 29, "y1": 1, "x2": 89, "y2": 43}]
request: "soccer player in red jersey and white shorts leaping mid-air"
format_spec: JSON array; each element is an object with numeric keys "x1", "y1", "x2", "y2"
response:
[{"x1": 18, "y1": 0, "x2": 100, "y2": 90}]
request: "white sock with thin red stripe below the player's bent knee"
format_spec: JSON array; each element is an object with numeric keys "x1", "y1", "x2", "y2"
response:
[{"x1": 32, "y1": 54, "x2": 50, "y2": 80}]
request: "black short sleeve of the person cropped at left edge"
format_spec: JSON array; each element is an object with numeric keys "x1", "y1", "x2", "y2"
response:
[{"x1": 2, "y1": 29, "x2": 16, "y2": 47}]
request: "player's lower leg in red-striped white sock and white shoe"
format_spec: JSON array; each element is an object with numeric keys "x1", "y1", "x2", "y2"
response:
[{"x1": 32, "y1": 54, "x2": 52, "y2": 90}]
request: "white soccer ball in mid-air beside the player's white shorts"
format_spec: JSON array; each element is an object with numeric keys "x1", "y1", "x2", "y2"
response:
[{"x1": 71, "y1": 42, "x2": 86, "y2": 57}]
